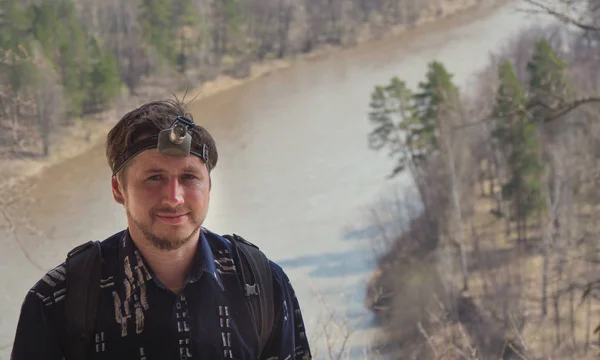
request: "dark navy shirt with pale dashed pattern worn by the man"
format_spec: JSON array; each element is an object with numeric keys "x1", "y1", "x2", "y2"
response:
[{"x1": 11, "y1": 229, "x2": 311, "y2": 360}]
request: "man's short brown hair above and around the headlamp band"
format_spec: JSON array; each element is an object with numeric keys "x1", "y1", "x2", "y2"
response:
[{"x1": 106, "y1": 100, "x2": 218, "y2": 176}]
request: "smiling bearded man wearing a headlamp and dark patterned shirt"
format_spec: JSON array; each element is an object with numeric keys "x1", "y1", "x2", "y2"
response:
[{"x1": 11, "y1": 100, "x2": 311, "y2": 360}]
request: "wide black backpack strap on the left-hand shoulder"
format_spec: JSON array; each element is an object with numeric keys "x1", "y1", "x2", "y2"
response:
[{"x1": 64, "y1": 241, "x2": 102, "y2": 360}]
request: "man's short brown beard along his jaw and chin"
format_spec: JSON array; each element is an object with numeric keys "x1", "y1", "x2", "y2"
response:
[{"x1": 127, "y1": 204, "x2": 203, "y2": 251}]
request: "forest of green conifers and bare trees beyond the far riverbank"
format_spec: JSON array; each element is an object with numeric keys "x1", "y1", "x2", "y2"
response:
[{"x1": 0, "y1": 0, "x2": 452, "y2": 154}]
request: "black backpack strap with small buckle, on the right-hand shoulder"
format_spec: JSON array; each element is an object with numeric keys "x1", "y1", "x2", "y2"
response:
[{"x1": 224, "y1": 234, "x2": 275, "y2": 354}]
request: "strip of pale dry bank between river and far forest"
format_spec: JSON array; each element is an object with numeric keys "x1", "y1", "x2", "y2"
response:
[{"x1": 0, "y1": 0, "x2": 508, "y2": 194}]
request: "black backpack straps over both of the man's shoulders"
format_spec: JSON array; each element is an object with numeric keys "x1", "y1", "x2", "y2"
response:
[{"x1": 64, "y1": 234, "x2": 275, "y2": 360}]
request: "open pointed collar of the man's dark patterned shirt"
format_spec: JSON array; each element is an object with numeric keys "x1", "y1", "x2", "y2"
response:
[{"x1": 119, "y1": 229, "x2": 225, "y2": 300}]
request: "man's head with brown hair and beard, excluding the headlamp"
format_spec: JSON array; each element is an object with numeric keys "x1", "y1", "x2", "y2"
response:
[{"x1": 106, "y1": 100, "x2": 218, "y2": 250}]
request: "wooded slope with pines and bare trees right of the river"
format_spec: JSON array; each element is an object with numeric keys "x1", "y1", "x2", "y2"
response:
[{"x1": 367, "y1": 0, "x2": 600, "y2": 360}]
